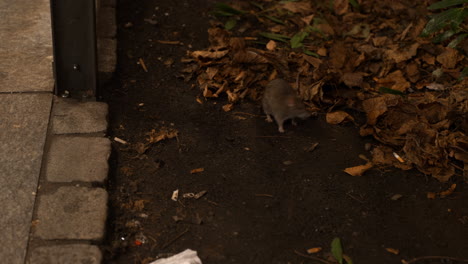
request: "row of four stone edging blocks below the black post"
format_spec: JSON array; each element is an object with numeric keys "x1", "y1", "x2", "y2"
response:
[{"x1": 26, "y1": 97, "x2": 111, "y2": 264}]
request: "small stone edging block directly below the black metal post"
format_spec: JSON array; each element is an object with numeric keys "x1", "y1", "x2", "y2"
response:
[{"x1": 52, "y1": 97, "x2": 108, "y2": 134}]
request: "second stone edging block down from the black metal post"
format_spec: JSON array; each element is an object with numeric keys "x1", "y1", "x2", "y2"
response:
[{"x1": 45, "y1": 136, "x2": 111, "y2": 182}]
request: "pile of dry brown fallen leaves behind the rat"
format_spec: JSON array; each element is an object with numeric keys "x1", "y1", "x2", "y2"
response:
[{"x1": 183, "y1": 0, "x2": 468, "y2": 181}]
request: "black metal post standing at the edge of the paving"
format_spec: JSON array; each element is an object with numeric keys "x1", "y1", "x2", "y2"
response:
[{"x1": 50, "y1": 0, "x2": 97, "y2": 98}]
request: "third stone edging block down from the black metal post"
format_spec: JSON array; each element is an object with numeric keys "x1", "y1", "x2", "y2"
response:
[{"x1": 34, "y1": 186, "x2": 108, "y2": 240}]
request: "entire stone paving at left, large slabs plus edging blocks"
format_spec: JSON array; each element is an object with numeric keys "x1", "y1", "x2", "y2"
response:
[{"x1": 0, "y1": 0, "x2": 116, "y2": 264}]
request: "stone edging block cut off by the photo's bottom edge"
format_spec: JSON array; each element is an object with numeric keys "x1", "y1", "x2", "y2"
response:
[{"x1": 26, "y1": 244, "x2": 102, "y2": 264}]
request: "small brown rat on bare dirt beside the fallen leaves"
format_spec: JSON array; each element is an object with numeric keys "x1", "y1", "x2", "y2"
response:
[{"x1": 262, "y1": 79, "x2": 310, "y2": 133}]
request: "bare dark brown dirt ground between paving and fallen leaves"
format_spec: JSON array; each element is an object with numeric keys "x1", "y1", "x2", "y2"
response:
[{"x1": 104, "y1": 0, "x2": 468, "y2": 264}]
